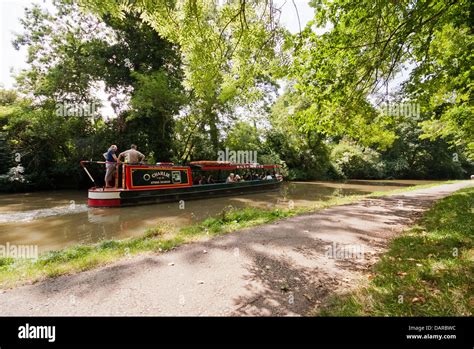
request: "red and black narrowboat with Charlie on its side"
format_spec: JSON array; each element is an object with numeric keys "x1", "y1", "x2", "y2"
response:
[{"x1": 81, "y1": 161, "x2": 283, "y2": 207}]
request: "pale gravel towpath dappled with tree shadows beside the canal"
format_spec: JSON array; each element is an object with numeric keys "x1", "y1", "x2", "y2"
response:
[{"x1": 0, "y1": 181, "x2": 472, "y2": 316}]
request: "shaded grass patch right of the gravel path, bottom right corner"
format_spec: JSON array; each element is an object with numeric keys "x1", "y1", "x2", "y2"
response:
[{"x1": 316, "y1": 188, "x2": 474, "y2": 316}]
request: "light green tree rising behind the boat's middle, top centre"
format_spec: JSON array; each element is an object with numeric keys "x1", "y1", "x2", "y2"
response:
[{"x1": 80, "y1": 0, "x2": 283, "y2": 153}]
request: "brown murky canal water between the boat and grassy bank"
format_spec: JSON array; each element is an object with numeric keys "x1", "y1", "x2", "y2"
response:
[{"x1": 0, "y1": 180, "x2": 433, "y2": 252}]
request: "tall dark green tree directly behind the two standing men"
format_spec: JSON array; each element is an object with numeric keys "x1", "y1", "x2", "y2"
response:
[{"x1": 15, "y1": 0, "x2": 184, "y2": 161}]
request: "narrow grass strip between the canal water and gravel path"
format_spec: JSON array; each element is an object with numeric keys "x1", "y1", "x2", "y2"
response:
[{"x1": 0, "y1": 179, "x2": 466, "y2": 288}]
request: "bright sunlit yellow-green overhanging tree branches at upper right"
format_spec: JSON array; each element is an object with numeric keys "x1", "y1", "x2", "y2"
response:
[{"x1": 290, "y1": 0, "x2": 472, "y2": 152}]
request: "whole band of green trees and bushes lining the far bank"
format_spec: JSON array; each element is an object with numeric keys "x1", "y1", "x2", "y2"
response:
[{"x1": 0, "y1": 0, "x2": 474, "y2": 190}]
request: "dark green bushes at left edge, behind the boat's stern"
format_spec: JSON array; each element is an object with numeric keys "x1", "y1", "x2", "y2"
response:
[{"x1": 0, "y1": 89, "x2": 112, "y2": 190}]
